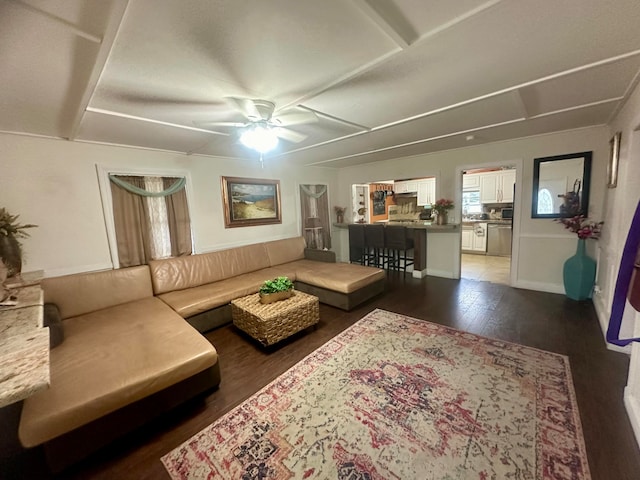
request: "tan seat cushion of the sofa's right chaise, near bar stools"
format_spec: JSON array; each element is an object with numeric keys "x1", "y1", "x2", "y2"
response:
[{"x1": 290, "y1": 260, "x2": 385, "y2": 293}]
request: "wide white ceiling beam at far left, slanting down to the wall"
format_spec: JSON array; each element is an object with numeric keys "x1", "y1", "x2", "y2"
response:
[{"x1": 67, "y1": 0, "x2": 129, "y2": 140}]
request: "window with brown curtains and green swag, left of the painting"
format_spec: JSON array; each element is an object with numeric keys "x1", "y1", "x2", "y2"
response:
[{"x1": 99, "y1": 168, "x2": 193, "y2": 268}]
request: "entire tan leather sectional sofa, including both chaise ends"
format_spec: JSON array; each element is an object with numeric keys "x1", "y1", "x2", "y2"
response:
[{"x1": 19, "y1": 237, "x2": 385, "y2": 470}]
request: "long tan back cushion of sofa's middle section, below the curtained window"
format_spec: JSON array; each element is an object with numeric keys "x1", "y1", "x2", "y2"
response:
[{"x1": 149, "y1": 243, "x2": 269, "y2": 295}]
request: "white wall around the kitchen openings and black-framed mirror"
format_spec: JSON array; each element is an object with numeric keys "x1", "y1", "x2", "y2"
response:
[{"x1": 336, "y1": 127, "x2": 609, "y2": 293}]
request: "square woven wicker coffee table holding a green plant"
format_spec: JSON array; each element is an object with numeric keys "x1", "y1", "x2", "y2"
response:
[{"x1": 231, "y1": 291, "x2": 320, "y2": 346}]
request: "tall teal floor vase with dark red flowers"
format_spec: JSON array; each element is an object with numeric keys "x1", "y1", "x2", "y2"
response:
[{"x1": 555, "y1": 215, "x2": 604, "y2": 300}]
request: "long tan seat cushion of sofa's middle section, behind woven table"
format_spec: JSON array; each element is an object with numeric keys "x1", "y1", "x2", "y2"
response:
[{"x1": 158, "y1": 264, "x2": 295, "y2": 318}]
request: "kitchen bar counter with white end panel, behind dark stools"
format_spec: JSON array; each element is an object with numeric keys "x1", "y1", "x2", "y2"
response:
[{"x1": 333, "y1": 221, "x2": 460, "y2": 278}]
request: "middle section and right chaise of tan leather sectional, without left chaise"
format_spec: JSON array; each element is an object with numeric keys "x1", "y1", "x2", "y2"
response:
[{"x1": 149, "y1": 237, "x2": 385, "y2": 331}]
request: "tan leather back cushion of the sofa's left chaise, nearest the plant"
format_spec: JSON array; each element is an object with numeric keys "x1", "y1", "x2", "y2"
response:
[{"x1": 41, "y1": 265, "x2": 153, "y2": 319}]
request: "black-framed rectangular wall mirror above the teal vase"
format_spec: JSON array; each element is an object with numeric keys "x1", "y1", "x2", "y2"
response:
[{"x1": 531, "y1": 152, "x2": 592, "y2": 218}]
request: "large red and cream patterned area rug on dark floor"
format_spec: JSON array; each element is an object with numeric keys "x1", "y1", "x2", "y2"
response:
[{"x1": 162, "y1": 310, "x2": 591, "y2": 480}]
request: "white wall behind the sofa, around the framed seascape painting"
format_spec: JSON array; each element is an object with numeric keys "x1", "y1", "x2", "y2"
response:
[{"x1": 0, "y1": 134, "x2": 336, "y2": 276}]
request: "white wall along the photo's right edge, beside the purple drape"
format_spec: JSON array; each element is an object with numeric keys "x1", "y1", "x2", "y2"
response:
[{"x1": 594, "y1": 80, "x2": 640, "y2": 443}]
